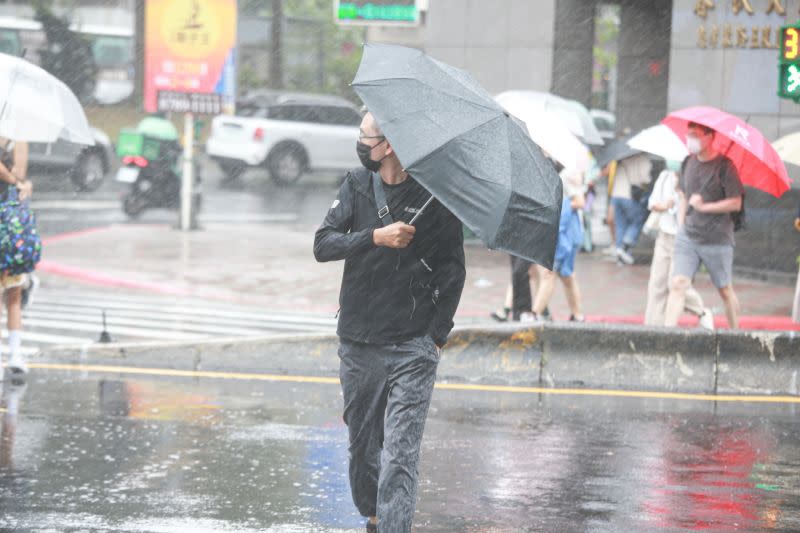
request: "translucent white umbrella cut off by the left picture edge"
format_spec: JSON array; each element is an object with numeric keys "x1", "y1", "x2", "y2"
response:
[{"x1": 0, "y1": 54, "x2": 94, "y2": 145}]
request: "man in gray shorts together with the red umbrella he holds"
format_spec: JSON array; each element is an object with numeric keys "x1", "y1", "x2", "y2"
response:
[{"x1": 662, "y1": 107, "x2": 792, "y2": 328}]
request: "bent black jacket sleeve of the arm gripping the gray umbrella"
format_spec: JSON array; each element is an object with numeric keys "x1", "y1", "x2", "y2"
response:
[{"x1": 314, "y1": 177, "x2": 374, "y2": 263}]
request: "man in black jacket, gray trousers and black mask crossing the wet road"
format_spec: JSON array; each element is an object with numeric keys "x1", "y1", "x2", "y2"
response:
[{"x1": 314, "y1": 113, "x2": 465, "y2": 533}]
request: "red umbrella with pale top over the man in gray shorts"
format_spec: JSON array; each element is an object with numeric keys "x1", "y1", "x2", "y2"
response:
[{"x1": 661, "y1": 107, "x2": 792, "y2": 198}]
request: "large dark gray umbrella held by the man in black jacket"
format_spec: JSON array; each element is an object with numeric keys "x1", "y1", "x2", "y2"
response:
[{"x1": 353, "y1": 44, "x2": 562, "y2": 268}]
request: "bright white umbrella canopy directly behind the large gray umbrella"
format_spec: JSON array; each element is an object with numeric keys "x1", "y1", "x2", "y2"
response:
[{"x1": 495, "y1": 92, "x2": 590, "y2": 172}]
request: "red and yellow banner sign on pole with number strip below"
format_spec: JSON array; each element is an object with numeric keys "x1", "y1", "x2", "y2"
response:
[{"x1": 144, "y1": 0, "x2": 237, "y2": 113}]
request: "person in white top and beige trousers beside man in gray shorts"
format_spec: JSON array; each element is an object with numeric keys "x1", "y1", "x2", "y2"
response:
[{"x1": 644, "y1": 161, "x2": 714, "y2": 330}]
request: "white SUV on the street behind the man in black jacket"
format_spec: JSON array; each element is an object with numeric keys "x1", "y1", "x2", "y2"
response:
[{"x1": 206, "y1": 92, "x2": 361, "y2": 184}]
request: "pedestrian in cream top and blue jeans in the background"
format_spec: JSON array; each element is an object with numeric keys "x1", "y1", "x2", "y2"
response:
[{"x1": 611, "y1": 154, "x2": 652, "y2": 265}]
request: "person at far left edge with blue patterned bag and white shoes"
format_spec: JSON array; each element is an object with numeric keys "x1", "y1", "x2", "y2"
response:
[{"x1": 0, "y1": 138, "x2": 41, "y2": 374}]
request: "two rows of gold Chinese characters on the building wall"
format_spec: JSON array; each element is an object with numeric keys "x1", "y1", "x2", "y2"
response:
[{"x1": 694, "y1": 0, "x2": 786, "y2": 50}]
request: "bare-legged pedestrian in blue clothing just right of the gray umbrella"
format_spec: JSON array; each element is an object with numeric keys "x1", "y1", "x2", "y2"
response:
[{"x1": 520, "y1": 171, "x2": 586, "y2": 322}]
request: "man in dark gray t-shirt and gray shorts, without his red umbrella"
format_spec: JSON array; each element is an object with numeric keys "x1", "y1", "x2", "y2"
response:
[{"x1": 665, "y1": 122, "x2": 744, "y2": 329}]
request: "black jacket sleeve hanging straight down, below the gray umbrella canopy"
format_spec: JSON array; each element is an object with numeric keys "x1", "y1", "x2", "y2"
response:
[{"x1": 429, "y1": 207, "x2": 466, "y2": 346}]
